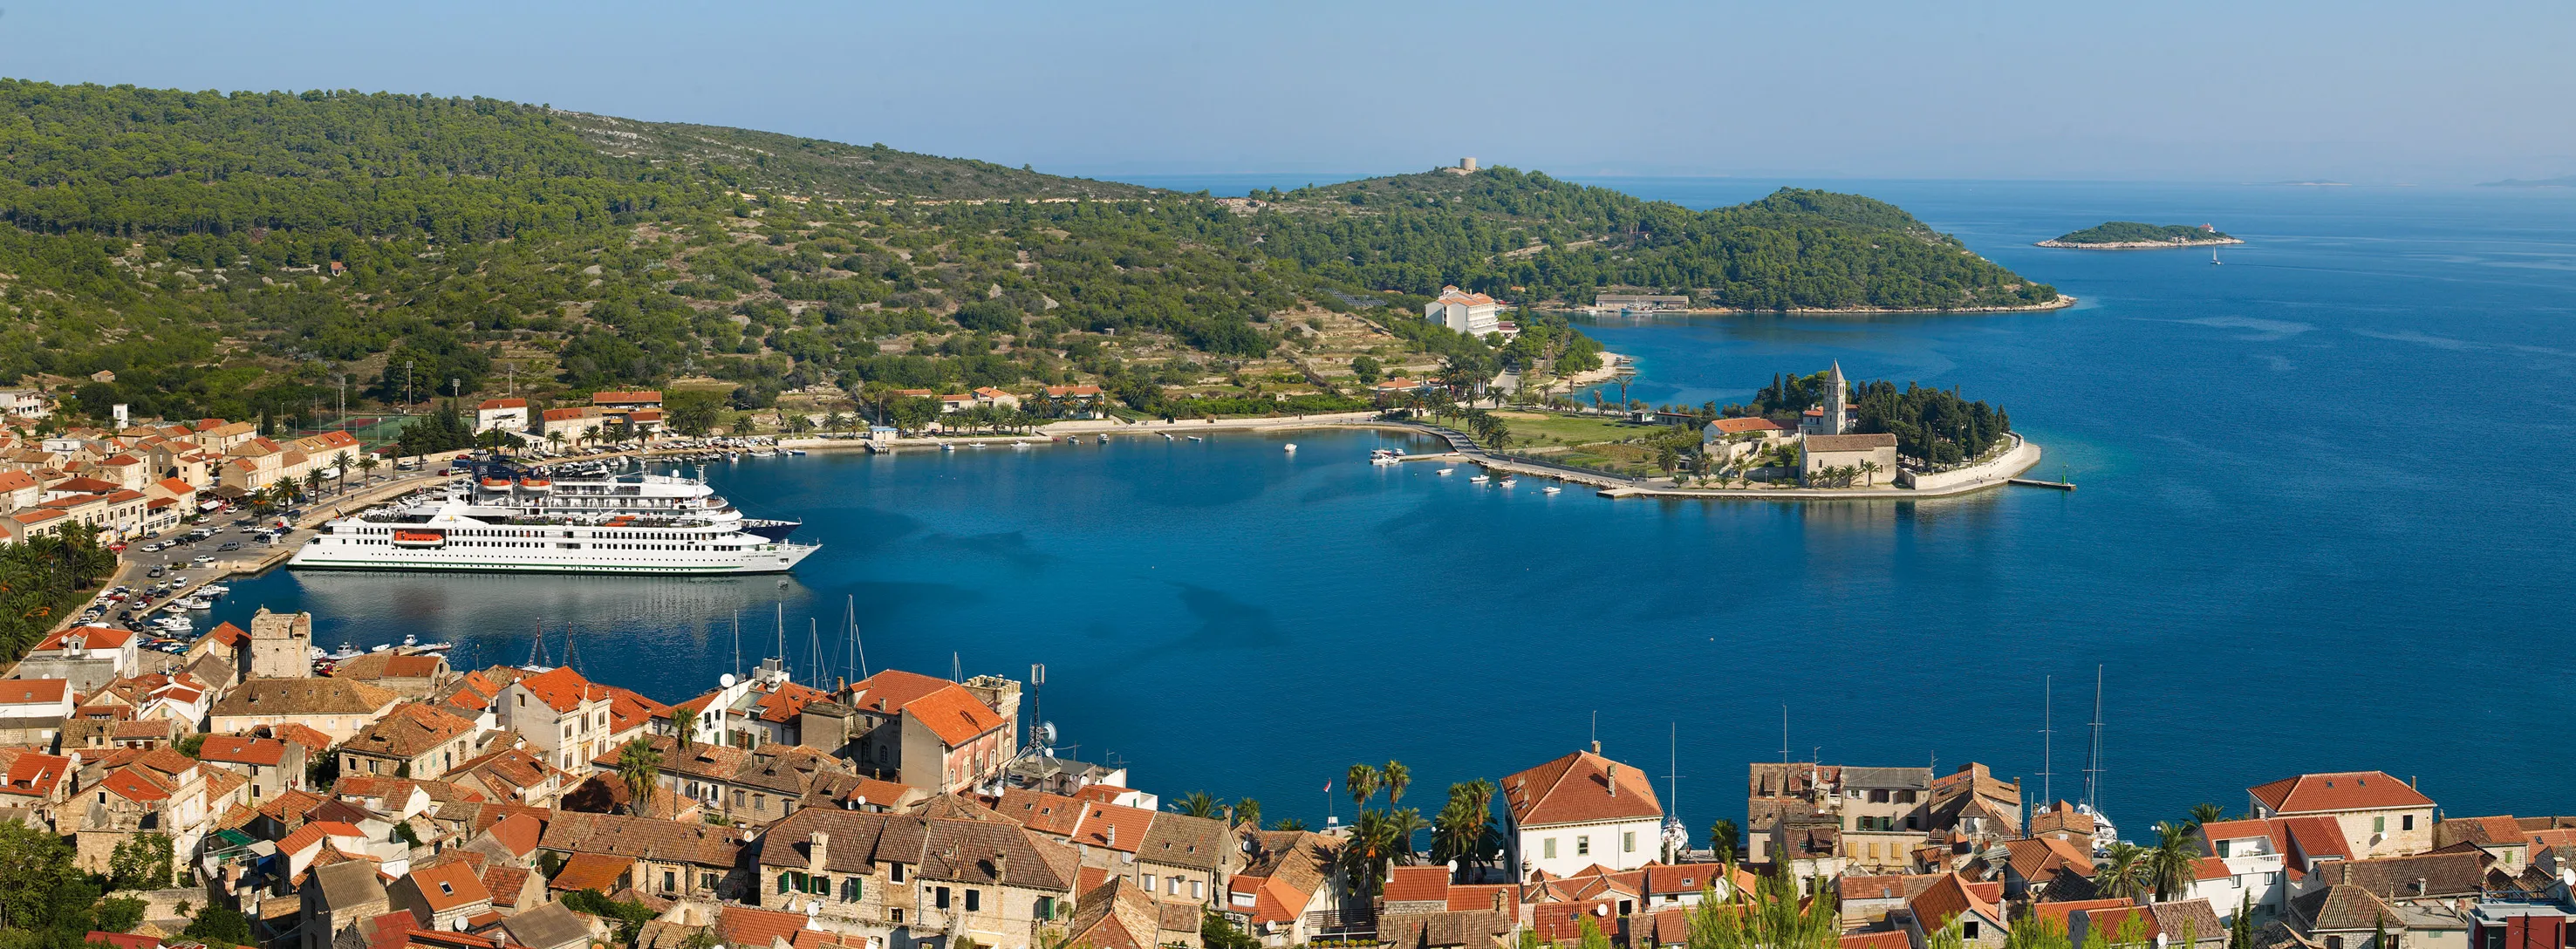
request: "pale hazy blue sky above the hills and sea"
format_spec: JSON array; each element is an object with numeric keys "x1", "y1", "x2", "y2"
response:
[{"x1": 0, "y1": 0, "x2": 2576, "y2": 186}]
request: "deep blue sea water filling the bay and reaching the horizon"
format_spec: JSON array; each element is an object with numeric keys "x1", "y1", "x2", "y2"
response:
[{"x1": 219, "y1": 178, "x2": 2576, "y2": 833}]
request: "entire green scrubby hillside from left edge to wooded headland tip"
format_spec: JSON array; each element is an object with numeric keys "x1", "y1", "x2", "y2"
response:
[{"x1": 0, "y1": 80, "x2": 2053, "y2": 423}]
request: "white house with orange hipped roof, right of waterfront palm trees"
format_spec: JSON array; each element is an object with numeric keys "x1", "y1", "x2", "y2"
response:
[{"x1": 1502, "y1": 742, "x2": 1664, "y2": 879}]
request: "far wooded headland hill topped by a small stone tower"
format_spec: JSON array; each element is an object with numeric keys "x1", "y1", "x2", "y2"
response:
[{"x1": 1247, "y1": 167, "x2": 2058, "y2": 310}]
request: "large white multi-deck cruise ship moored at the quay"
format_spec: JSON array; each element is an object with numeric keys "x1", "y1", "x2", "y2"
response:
[{"x1": 286, "y1": 464, "x2": 819, "y2": 575}]
